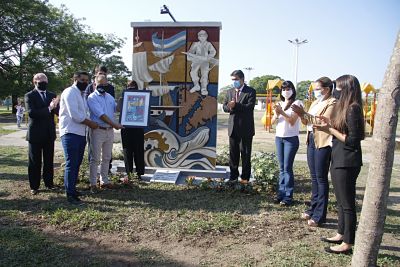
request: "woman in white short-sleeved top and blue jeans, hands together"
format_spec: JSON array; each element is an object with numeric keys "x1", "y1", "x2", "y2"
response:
[{"x1": 272, "y1": 81, "x2": 302, "y2": 206}]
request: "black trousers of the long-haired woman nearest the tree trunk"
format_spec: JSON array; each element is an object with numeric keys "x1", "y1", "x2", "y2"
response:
[{"x1": 331, "y1": 167, "x2": 361, "y2": 244}]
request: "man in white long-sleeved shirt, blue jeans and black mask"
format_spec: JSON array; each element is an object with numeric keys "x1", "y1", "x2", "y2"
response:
[{"x1": 59, "y1": 71, "x2": 98, "y2": 205}]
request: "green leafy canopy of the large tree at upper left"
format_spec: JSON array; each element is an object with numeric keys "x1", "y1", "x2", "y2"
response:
[{"x1": 0, "y1": 0, "x2": 130, "y2": 101}]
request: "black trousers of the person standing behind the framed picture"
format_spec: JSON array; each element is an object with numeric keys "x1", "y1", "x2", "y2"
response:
[{"x1": 121, "y1": 128, "x2": 144, "y2": 175}]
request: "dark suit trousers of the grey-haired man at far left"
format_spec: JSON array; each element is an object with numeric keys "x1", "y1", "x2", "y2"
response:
[{"x1": 28, "y1": 141, "x2": 54, "y2": 190}]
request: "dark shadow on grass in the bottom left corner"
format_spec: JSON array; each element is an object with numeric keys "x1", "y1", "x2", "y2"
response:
[{"x1": 0, "y1": 224, "x2": 189, "y2": 266}]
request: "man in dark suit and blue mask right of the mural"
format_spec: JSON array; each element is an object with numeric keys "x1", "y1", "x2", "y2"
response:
[{"x1": 223, "y1": 70, "x2": 256, "y2": 182}]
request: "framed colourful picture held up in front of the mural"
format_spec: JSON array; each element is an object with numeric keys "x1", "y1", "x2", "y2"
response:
[{"x1": 120, "y1": 90, "x2": 151, "y2": 127}]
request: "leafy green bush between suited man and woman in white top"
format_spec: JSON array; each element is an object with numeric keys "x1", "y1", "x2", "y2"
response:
[{"x1": 251, "y1": 152, "x2": 279, "y2": 192}]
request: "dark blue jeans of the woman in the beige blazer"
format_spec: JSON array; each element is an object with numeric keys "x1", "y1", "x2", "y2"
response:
[{"x1": 306, "y1": 133, "x2": 332, "y2": 223}]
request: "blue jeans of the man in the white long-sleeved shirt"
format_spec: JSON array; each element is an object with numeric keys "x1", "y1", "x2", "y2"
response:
[{"x1": 61, "y1": 133, "x2": 86, "y2": 197}]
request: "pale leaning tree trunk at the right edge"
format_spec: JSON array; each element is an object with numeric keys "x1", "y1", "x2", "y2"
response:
[{"x1": 351, "y1": 32, "x2": 400, "y2": 267}]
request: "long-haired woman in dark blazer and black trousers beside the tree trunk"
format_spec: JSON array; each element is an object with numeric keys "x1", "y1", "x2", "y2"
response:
[{"x1": 314, "y1": 75, "x2": 365, "y2": 254}]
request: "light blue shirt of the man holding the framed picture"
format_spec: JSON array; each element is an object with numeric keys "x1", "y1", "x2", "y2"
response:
[{"x1": 87, "y1": 90, "x2": 116, "y2": 127}]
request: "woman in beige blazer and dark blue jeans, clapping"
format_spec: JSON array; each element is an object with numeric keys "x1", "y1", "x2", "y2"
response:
[{"x1": 292, "y1": 77, "x2": 336, "y2": 227}]
